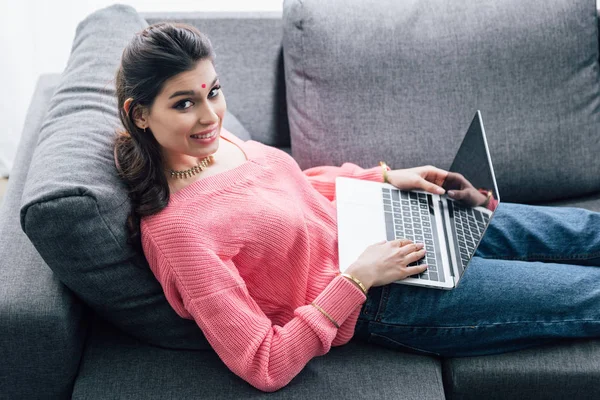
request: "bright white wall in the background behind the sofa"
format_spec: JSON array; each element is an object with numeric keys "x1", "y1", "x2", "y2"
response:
[{"x1": 0, "y1": 0, "x2": 283, "y2": 176}]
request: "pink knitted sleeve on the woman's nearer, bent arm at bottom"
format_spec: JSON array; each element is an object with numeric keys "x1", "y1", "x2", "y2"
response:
[{"x1": 142, "y1": 227, "x2": 365, "y2": 392}]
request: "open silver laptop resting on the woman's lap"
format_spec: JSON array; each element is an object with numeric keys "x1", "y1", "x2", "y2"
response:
[{"x1": 336, "y1": 110, "x2": 500, "y2": 290}]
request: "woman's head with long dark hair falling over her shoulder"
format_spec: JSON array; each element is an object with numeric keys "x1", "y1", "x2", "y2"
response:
[{"x1": 115, "y1": 23, "x2": 221, "y2": 245}]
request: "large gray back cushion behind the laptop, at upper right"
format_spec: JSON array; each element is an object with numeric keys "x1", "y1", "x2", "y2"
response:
[{"x1": 283, "y1": 0, "x2": 600, "y2": 202}]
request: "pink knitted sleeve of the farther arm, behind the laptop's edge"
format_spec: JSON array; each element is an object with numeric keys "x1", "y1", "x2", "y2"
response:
[{"x1": 302, "y1": 163, "x2": 389, "y2": 201}]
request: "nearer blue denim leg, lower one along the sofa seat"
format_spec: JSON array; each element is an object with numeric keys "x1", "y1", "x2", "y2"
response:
[{"x1": 358, "y1": 257, "x2": 600, "y2": 357}]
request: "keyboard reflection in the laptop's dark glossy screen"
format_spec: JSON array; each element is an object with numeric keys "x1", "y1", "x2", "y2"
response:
[{"x1": 448, "y1": 201, "x2": 489, "y2": 274}]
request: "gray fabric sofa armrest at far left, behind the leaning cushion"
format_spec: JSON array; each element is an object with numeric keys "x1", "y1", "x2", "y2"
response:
[{"x1": 0, "y1": 77, "x2": 87, "y2": 399}]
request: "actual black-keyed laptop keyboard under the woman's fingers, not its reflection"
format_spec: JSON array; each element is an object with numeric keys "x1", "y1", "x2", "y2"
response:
[{"x1": 382, "y1": 188, "x2": 445, "y2": 282}]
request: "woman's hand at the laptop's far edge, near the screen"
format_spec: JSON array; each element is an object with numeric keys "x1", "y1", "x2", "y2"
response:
[{"x1": 387, "y1": 165, "x2": 448, "y2": 194}]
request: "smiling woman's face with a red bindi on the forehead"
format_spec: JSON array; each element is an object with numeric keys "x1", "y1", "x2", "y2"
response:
[{"x1": 146, "y1": 59, "x2": 227, "y2": 170}]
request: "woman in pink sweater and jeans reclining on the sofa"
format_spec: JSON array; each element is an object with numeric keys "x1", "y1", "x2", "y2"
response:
[{"x1": 115, "y1": 23, "x2": 600, "y2": 391}]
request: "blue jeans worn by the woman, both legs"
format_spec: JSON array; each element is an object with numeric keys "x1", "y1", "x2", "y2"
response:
[{"x1": 355, "y1": 203, "x2": 600, "y2": 357}]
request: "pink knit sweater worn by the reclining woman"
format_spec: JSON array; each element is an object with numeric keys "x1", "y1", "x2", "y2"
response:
[{"x1": 141, "y1": 130, "x2": 383, "y2": 391}]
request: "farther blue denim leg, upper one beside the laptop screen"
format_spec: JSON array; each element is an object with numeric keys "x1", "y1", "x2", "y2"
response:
[{"x1": 475, "y1": 203, "x2": 600, "y2": 266}]
